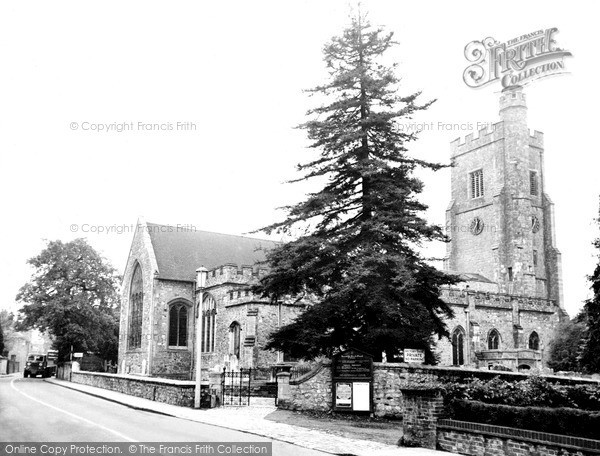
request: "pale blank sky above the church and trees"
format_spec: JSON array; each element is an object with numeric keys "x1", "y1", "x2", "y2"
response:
[{"x1": 0, "y1": 0, "x2": 600, "y2": 315}]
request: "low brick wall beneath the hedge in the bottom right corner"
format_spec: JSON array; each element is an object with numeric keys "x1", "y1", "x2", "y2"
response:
[{"x1": 437, "y1": 420, "x2": 600, "y2": 456}]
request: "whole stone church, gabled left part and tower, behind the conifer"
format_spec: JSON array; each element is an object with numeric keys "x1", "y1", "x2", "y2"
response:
[{"x1": 119, "y1": 87, "x2": 566, "y2": 379}]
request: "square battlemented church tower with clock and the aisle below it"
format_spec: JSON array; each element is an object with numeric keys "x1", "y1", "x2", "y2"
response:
[{"x1": 438, "y1": 86, "x2": 567, "y2": 370}]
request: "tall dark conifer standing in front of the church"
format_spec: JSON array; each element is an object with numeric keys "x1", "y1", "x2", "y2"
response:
[{"x1": 256, "y1": 15, "x2": 455, "y2": 362}]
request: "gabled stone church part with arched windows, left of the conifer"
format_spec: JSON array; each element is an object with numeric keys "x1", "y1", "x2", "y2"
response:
[{"x1": 119, "y1": 220, "x2": 304, "y2": 379}]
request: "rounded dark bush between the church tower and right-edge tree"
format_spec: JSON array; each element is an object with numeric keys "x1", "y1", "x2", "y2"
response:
[{"x1": 548, "y1": 312, "x2": 586, "y2": 372}]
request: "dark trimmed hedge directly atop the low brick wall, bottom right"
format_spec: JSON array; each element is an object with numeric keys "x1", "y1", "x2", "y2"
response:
[{"x1": 448, "y1": 399, "x2": 600, "y2": 440}]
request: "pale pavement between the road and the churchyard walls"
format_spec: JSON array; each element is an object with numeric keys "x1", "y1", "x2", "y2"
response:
[{"x1": 45, "y1": 378, "x2": 454, "y2": 456}]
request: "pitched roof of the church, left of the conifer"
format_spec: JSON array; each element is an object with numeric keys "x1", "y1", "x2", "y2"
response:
[{"x1": 146, "y1": 223, "x2": 277, "y2": 282}]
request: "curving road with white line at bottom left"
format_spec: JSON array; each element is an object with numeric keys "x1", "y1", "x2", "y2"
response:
[{"x1": 0, "y1": 376, "x2": 327, "y2": 456}]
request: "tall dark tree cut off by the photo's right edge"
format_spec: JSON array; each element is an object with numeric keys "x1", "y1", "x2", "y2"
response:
[{"x1": 580, "y1": 211, "x2": 600, "y2": 373}]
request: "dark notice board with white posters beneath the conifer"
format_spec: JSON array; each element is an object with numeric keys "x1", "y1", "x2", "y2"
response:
[{"x1": 332, "y1": 349, "x2": 373, "y2": 412}]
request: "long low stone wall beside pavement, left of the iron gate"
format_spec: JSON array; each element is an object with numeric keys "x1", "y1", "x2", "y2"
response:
[{"x1": 71, "y1": 371, "x2": 195, "y2": 407}]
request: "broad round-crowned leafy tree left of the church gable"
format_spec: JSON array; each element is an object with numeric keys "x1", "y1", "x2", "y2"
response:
[{"x1": 17, "y1": 239, "x2": 119, "y2": 360}]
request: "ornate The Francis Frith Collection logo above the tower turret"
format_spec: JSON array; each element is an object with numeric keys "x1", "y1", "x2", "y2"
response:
[{"x1": 463, "y1": 27, "x2": 572, "y2": 88}]
